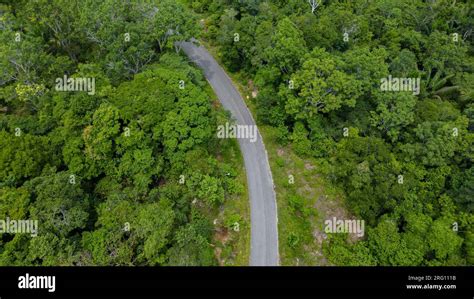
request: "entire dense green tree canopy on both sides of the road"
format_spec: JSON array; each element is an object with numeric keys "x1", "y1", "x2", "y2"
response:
[{"x1": 0, "y1": 0, "x2": 474, "y2": 266}]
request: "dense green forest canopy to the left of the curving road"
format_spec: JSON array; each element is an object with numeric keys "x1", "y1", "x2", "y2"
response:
[{"x1": 0, "y1": 0, "x2": 244, "y2": 265}]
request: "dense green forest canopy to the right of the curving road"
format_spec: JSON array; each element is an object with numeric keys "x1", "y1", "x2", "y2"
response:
[{"x1": 187, "y1": 0, "x2": 474, "y2": 265}]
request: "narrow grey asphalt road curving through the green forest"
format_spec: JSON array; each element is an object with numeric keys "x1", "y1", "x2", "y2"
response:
[{"x1": 180, "y1": 42, "x2": 279, "y2": 266}]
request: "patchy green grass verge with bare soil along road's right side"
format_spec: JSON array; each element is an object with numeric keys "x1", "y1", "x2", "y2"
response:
[{"x1": 259, "y1": 126, "x2": 345, "y2": 266}]
